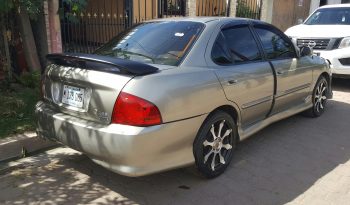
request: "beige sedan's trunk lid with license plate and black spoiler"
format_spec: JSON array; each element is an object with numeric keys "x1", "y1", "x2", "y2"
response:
[{"x1": 43, "y1": 54, "x2": 158, "y2": 124}]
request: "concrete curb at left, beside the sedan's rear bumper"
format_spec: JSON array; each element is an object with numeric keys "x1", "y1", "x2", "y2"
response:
[{"x1": 0, "y1": 132, "x2": 58, "y2": 162}]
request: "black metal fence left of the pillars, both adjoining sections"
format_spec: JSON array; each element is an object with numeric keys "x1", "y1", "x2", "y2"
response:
[{"x1": 60, "y1": 0, "x2": 185, "y2": 53}]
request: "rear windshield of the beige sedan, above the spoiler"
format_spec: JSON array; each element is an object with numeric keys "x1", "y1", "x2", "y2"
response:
[{"x1": 95, "y1": 21, "x2": 204, "y2": 65}]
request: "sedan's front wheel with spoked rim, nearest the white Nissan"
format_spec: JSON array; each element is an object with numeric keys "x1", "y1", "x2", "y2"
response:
[{"x1": 303, "y1": 76, "x2": 329, "y2": 118}]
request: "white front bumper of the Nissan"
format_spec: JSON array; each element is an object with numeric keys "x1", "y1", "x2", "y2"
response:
[{"x1": 314, "y1": 48, "x2": 350, "y2": 76}]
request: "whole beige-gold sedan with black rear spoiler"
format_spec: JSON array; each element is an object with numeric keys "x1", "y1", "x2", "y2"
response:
[{"x1": 36, "y1": 17, "x2": 331, "y2": 177}]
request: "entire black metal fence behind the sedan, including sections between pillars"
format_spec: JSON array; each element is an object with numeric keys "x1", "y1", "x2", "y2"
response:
[{"x1": 60, "y1": 0, "x2": 262, "y2": 53}]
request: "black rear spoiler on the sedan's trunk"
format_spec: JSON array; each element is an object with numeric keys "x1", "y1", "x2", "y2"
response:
[{"x1": 46, "y1": 53, "x2": 158, "y2": 75}]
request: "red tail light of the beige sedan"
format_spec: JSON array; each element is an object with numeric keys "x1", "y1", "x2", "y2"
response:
[{"x1": 112, "y1": 92, "x2": 162, "y2": 127}]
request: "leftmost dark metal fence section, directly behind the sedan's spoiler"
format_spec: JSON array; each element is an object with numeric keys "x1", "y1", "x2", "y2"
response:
[{"x1": 60, "y1": 0, "x2": 130, "y2": 53}]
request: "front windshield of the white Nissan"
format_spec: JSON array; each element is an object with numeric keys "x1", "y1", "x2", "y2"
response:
[{"x1": 305, "y1": 8, "x2": 350, "y2": 25}]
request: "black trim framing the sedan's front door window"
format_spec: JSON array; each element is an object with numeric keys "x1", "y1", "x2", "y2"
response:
[{"x1": 251, "y1": 23, "x2": 299, "y2": 61}]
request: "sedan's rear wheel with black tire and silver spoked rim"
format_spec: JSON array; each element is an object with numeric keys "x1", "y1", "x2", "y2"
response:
[{"x1": 193, "y1": 111, "x2": 237, "y2": 178}]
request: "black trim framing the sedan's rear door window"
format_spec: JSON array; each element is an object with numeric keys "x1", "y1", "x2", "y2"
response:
[{"x1": 210, "y1": 21, "x2": 267, "y2": 67}]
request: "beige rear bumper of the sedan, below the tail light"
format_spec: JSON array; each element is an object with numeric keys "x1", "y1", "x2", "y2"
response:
[{"x1": 35, "y1": 102, "x2": 206, "y2": 176}]
